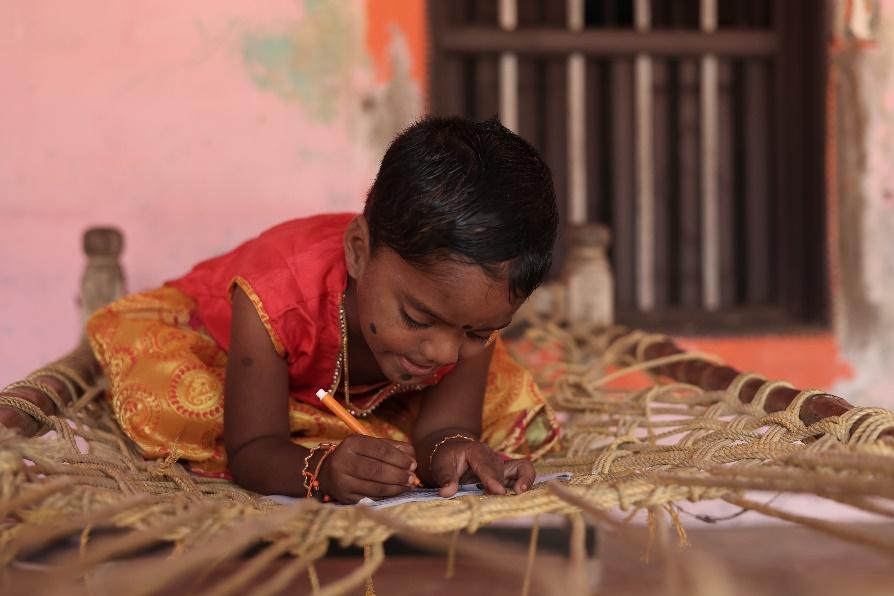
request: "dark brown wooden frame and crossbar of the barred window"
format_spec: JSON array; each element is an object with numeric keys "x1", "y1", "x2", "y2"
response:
[{"x1": 429, "y1": 0, "x2": 829, "y2": 334}]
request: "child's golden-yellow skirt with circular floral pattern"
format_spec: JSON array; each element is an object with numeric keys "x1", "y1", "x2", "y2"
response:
[{"x1": 87, "y1": 286, "x2": 558, "y2": 475}]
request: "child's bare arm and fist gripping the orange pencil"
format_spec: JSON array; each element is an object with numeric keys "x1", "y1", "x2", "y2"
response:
[{"x1": 224, "y1": 287, "x2": 415, "y2": 502}]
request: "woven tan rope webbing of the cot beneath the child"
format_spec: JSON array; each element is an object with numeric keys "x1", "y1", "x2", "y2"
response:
[{"x1": 0, "y1": 319, "x2": 894, "y2": 594}]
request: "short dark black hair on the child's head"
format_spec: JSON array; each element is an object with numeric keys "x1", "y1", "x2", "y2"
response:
[{"x1": 363, "y1": 116, "x2": 559, "y2": 298}]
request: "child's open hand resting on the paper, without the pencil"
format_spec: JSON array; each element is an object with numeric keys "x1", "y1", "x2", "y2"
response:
[{"x1": 431, "y1": 439, "x2": 534, "y2": 497}]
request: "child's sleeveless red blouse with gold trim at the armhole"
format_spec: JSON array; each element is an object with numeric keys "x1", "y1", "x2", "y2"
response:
[{"x1": 167, "y1": 213, "x2": 446, "y2": 408}]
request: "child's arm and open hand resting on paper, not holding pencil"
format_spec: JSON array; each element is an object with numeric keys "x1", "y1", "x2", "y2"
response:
[{"x1": 413, "y1": 346, "x2": 534, "y2": 497}]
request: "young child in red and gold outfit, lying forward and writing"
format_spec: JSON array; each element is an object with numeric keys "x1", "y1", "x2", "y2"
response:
[{"x1": 87, "y1": 117, "x2": 558, "y2": 503}]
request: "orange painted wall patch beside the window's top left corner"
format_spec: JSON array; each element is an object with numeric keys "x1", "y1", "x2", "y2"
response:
[{"x1": 366, "y1": 0, "x2": 428, "y2": 88}]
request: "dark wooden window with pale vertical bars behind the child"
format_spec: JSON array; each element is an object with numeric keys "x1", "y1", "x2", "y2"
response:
[{"x1": 429, "y1": 0, "x2": 828, "y2": 333}]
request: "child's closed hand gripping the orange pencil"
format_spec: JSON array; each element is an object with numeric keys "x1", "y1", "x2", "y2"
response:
[{"x1": 317, "y1": 435, "x2": 416, "y2": 503}]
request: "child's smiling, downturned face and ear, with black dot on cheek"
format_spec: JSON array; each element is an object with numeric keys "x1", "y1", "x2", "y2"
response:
[{"x1": 345, "y1": 216, "x2": 522, "y2": 384}]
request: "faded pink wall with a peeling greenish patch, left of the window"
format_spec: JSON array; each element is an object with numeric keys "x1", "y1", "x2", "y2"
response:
[{"x1": 0, "y1": 0, "x2": 423, "y2": 384}]
